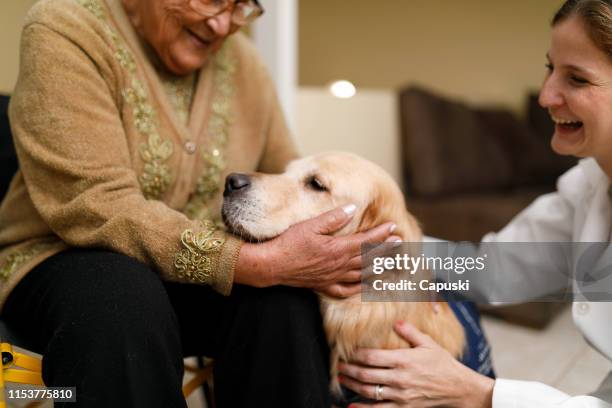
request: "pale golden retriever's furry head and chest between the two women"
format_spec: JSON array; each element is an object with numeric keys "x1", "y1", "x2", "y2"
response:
[{"x1": 223, "y1": 152, "x2": 465, "y2": 392}]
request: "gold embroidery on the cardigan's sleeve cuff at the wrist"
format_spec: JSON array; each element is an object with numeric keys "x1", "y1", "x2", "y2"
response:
[{"x1": 174, "y1": 221, "x2": 225, "y2": 284}]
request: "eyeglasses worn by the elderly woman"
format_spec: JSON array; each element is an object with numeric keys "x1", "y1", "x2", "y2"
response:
[{"x1": 187, "y1": 0, "x2": 264, "y2": 27}]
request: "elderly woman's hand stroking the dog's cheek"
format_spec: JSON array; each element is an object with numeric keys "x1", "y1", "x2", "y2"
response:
[{"x1": 235, "y1": 206, "x2": 399, "y2": 297}]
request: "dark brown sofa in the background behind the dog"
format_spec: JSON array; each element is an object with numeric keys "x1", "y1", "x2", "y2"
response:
[{"x1": 400, "y1": 87, "x2": 576, "y2": 327}]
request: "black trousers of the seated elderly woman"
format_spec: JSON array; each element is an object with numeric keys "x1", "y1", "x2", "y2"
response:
[{"x1": 2, "y1": 249, "x2": 330, "y2": 408}]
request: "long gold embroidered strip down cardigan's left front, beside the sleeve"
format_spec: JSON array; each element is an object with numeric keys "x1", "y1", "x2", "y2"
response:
[{"x1": 78, "y1": 0, "x2": 174, "y2": 200}]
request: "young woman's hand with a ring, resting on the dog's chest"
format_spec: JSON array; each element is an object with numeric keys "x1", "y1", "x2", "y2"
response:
[{"x1": 339, "y1": 322, "x2": 495, "y2": 408}]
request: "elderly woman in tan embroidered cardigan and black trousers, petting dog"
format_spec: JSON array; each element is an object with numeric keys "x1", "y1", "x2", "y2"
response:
[{"x1": 0, "y1": 0, "x2": 392, "y2": 408}]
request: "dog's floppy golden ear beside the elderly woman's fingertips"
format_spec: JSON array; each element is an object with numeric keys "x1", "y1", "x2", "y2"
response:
[{"x1": 357, "y1": 182, "x2": 423, "y2": 242}]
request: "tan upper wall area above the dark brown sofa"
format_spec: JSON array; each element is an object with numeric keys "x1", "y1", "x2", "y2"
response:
[{"x1": 298, "y1": 0, "x2": 563, "y2": 112}]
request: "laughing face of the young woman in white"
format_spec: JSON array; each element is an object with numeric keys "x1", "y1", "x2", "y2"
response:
[{"x1": 540, "y1": 16, "x2": 612, "y2": 166}]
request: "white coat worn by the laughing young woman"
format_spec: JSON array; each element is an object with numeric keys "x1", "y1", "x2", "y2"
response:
[{"x1": 483, "y1": 158, "x2": 612, "y2": 408}]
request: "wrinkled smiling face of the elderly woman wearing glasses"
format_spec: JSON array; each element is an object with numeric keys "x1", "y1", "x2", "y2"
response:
[{"x1": 122, "y1": 0, "x2": 232, "y2": 75}]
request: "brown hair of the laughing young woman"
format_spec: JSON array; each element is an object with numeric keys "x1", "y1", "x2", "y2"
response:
[{"x1": 552, "y1": 0, "x2": 612, "y2": 58}]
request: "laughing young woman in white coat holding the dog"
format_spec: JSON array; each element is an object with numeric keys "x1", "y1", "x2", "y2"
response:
[{"x1": 340, "y1": 0, "x2": 612, "y2": 408}]
